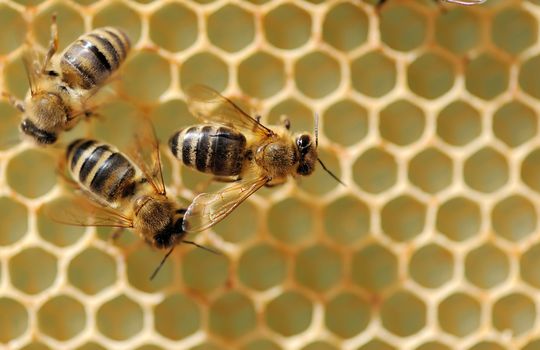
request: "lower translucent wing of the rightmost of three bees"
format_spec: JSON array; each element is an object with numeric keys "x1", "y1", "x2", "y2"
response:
[{"x1": 182, "y1": 170, "x2": 269, "y2": 232}]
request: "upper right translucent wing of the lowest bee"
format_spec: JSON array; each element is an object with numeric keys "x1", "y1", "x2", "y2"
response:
[{"x1": 127, "y1": 119, "x2": 166, "y2": 195}]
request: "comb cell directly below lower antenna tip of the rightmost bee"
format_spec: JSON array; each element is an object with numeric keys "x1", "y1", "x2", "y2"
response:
[{"x1": 323, "y1": 196, "x2": 371, "y2": 245}]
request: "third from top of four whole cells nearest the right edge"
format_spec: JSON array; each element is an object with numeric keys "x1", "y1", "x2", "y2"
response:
[{"x1": 491, "y1": 195, "x2": 538, "y2": 242}]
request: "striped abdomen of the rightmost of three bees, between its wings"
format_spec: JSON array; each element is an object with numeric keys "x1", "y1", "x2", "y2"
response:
[{"x1": 169, "y1": 125, "x2": 246, "y2": 176}]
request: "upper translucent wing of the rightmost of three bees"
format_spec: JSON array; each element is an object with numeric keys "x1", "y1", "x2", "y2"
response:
[{"x1": 186, "y1": 85, "x2": 274, "y2": 138}]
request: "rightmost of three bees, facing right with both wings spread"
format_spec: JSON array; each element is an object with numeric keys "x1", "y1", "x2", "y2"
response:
[{"x1": 169, "y1": 86, "x2": 343, "y2": 232}]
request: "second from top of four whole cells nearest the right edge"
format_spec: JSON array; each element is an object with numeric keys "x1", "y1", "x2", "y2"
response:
[{"x1": 493, "y1": 101, "x2": 538, "y2": 147}]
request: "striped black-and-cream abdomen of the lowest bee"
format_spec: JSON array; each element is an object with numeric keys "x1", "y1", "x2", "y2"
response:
[{"x1": 66, "y1": 139, "x2": 137, "y2": 206}]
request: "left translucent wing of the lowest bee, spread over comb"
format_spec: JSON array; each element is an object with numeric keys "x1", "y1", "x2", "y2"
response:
[{"x1": 46, "y1": 196, "x2": 133, "y2": 228}]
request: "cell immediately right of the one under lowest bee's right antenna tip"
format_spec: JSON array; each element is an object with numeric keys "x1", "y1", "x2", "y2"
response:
[{"x1": 237, "y1": 244, "x2": 288, "y2": 290}]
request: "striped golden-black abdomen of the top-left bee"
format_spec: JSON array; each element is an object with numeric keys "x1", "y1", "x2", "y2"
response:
[{"x1": 60, "y1": 27, "x2": 131, "y2": 90}]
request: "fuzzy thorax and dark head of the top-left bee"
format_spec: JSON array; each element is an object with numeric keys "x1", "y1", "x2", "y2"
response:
[{"x1": 20, "y1": 93, "x2": 67, "y2": 145}]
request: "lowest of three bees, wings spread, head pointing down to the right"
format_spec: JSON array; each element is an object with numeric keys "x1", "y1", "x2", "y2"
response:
[{"x1": 60, "y1": 123, "x2": 215, "y2": 279}]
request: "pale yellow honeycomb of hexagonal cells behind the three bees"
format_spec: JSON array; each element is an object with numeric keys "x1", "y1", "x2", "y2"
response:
[{"x1": 0, "y1": 0, "x2": 540, "y2": 350}]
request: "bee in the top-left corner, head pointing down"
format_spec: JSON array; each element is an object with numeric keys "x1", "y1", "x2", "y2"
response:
[{"x1": 4, "y1": 16, "x2": 131, "y2": 146}]
